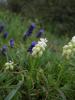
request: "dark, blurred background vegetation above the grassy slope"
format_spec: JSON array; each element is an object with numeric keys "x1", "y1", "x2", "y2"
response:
[{"x1": 8, "y1": 0, "x2": 75, "y2": 34}]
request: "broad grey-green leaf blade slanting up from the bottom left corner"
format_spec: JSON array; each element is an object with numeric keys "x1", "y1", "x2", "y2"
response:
[{"x1": 4, "y1": 81, "x2": 23, "y2": 100}]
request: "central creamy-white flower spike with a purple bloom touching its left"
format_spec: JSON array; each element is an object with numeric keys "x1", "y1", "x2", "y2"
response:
[{"x1": 31, "y1": 38, "x2": 47, "y2": 57}]
